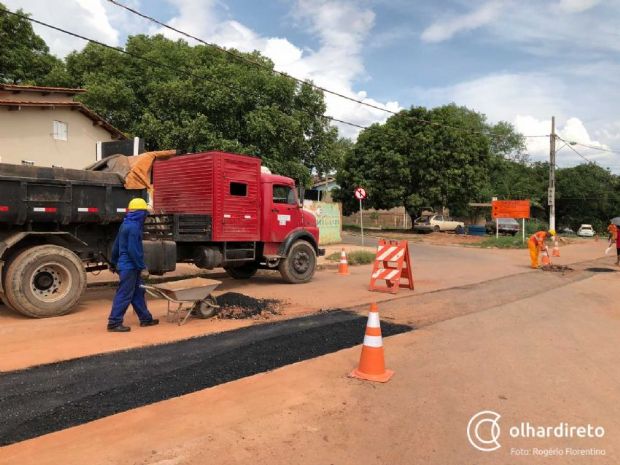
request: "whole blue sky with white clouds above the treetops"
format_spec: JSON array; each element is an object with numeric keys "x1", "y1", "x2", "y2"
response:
[{"x1": 8, "y1": 0, "x2": 620, "y2": 167}]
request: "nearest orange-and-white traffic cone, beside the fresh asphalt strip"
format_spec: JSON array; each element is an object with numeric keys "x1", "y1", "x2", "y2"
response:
[{"x1": 349, "y1": 303, "x2": 394, "y2": 383}]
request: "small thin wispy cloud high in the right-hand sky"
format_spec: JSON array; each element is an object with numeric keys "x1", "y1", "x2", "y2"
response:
[{"x1": 421, "y1": 0, "x2": 505, "y2": 42}]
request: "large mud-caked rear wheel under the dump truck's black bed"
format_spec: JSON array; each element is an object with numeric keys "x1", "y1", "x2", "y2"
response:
[{"x1": 4, "y1": 245, "x2": 86, "y2": 318}]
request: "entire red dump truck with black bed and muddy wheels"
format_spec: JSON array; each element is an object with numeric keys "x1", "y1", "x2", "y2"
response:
[{"x1": 0, "y1": 152, "x2": 324, "y2": 318}]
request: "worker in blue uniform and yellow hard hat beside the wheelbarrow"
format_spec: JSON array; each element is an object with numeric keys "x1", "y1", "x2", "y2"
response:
[{"x1": 108, "y1": 198, "x2": 159, "y2": 333}]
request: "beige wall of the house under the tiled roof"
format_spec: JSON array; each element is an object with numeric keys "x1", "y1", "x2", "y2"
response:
[{"x1": 0, "y1": 107, "x2": 112, "y2": 169}]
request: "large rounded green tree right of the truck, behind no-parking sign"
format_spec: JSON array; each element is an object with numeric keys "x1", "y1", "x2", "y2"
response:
[{"x1": 337, "y1": 104, "x2": 490, "y2": 217}]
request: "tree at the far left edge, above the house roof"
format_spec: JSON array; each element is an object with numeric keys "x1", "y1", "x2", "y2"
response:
[{"x1": 0, "y1": 3, "x2": 63, "y2": 84}]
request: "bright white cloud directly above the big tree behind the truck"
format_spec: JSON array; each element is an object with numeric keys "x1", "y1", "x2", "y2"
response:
[{"x1": 159, "y1": 0, "x2": 400, "y2": 137}]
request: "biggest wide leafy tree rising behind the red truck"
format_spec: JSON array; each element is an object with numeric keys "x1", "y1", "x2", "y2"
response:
[{"x1": 66, "y1": 35, "x2": 342, "y2": 185}]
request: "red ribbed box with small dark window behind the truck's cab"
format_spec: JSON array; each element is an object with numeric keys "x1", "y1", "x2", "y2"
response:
[{"x1": 153, "y1": 152, "x2": 261, "y2": 242}]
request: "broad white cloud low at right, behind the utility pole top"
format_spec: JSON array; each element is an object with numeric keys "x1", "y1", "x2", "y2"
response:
[{"x1": 406, "y1": 70, "x2": 620, "y2": 166}]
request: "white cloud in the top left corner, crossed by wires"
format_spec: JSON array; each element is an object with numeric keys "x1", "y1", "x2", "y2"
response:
[{"x1": 2, "y1": 0, "x2": 120, "y2": 57}]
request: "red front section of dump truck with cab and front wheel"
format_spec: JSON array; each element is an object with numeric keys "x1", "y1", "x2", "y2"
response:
[{"x1": 150, "y1": 152, "x2": 324, "y2": 283}]
